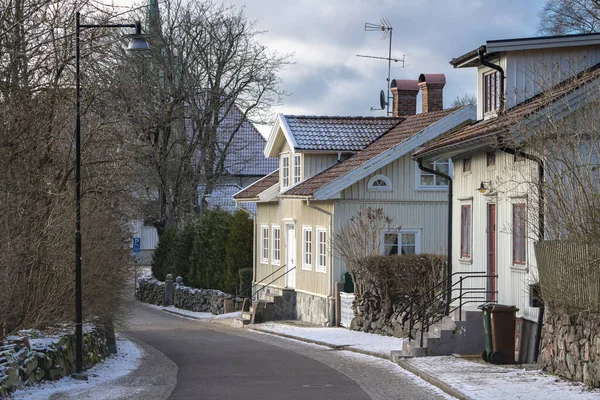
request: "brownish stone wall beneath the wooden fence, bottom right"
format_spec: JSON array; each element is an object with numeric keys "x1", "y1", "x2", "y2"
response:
[{"x1": 538, "y1": 312, "x2": 600, "y2": 387}]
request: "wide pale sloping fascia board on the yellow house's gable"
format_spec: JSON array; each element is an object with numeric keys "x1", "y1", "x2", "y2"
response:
[{"x1": 314, "y1": 104, "x2": 477, "y2": 200}]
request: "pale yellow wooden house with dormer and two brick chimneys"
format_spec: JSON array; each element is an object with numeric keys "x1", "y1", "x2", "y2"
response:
[{"x1": 234, "y1": 74, "x2": 476, "y2": 325}]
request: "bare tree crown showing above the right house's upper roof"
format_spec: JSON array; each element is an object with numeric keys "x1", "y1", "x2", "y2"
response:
[{"x1": 538, "y1": 0, "x2": 600, "y2": 35}]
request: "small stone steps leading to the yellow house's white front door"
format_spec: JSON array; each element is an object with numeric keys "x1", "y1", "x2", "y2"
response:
[{"x1": 241, "y1": 287, "x2": 296, "y2": 325}]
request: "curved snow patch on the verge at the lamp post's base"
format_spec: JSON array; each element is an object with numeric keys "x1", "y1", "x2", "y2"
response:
[{"x1": 13, "y1": 337, "x2": 143, "y2": 400}]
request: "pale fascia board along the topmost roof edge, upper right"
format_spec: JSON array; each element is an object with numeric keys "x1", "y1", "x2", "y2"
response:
[{"x1": 486, "y1": 35, "x2": 600, "y2": 53}]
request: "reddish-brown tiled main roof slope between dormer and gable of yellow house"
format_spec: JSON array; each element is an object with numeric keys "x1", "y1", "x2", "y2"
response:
[{"x1": 283, "y1": 108, "x2": 457, "y2": 196}]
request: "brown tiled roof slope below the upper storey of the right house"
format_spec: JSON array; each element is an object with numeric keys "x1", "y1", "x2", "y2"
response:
[{"x1": 415, "y1": 64, "x2": 600, "y2": 157}]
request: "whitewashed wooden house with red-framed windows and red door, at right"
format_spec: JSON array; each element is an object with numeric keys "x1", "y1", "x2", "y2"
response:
[{"x1": 415, "y1": 34, "x2": 600, "y2": 361}]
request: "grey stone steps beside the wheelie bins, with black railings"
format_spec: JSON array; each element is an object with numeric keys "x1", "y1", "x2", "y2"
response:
[{"x1": 391, "y1": 308, "x2": 485, "y2": 361}]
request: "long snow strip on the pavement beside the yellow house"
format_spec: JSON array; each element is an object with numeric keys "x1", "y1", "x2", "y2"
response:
[{"x1": 257, "y1": 322, "x2": 404, "y2": 358}]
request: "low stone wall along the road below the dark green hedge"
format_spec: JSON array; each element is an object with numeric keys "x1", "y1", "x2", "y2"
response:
[{"x1": 136, "y1": 279, "x2": 243, "y2": 314}]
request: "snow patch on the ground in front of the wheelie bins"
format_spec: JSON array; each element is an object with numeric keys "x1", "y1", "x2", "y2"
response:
[{"x1": 408, "y1": 356, "x2": 600, "y2": 400}]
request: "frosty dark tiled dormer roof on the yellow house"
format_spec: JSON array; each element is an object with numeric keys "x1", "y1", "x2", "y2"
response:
[{"x1": 284, "y1": 115, "x2": 403, "y2": 151}]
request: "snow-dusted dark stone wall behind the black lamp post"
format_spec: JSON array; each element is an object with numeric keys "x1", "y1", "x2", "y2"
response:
[{"x1": 0, "y1": 329, "x2": 109, "y2": 398}]
